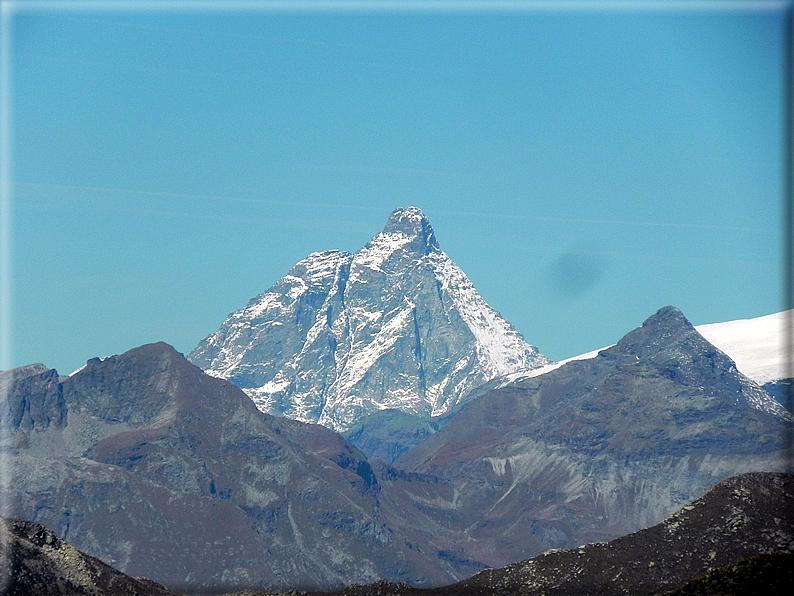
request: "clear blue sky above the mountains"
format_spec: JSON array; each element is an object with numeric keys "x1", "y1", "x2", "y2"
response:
[{"x1": 3, "y1": 1, "x2": 785, "y2": 374}]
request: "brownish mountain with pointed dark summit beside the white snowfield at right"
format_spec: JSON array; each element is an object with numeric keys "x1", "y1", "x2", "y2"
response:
[{"x1": 387, "y1": 307, "x2": 792, "y2": 566}]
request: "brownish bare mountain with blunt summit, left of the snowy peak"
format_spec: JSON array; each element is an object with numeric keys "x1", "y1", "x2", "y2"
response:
[{"x1": 0, "y1": 344, "x2": 463, "y2": 591}]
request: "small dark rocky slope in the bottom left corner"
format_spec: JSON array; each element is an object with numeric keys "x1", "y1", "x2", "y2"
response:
[{"x1": 0, "y1": 518, "x2": 178, "y2": 596}]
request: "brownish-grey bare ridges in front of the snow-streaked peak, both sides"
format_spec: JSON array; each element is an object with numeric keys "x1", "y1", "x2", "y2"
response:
[{"x1": 0, "y1": 308, "x2": 791, "y2": 590}]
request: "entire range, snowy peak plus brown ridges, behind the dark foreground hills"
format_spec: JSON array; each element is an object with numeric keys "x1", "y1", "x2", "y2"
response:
[{"x1": 0, "y1": 208, "x2": 794, "y2": 593}]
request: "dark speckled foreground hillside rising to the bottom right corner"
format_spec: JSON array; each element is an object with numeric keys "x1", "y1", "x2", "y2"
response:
[{"x1": 241, "y1": 473, "x2": 794, "y2": 596}]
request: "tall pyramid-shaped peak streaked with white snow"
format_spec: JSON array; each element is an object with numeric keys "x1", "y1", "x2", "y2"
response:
[{"x1": 189, "y1": 207, "x2": 550, "y2": 431}]
